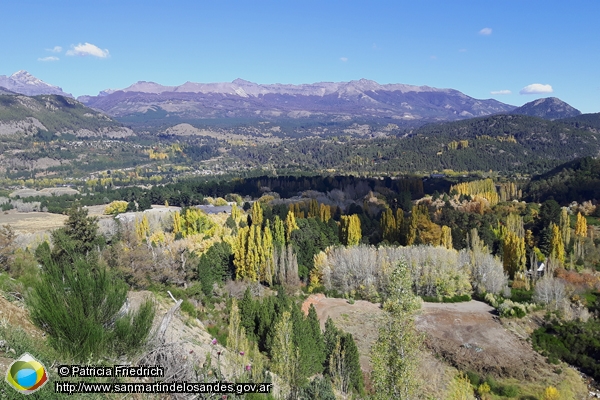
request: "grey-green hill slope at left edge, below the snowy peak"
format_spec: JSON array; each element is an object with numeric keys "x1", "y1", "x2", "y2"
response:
[{"x1": 0, "y1": 95, "x2": 133, "y2": 137}]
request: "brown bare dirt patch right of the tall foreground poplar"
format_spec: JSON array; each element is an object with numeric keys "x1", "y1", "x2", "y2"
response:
[{"x1": 417, "y1": 301, "x2": 546, "y2": 380}]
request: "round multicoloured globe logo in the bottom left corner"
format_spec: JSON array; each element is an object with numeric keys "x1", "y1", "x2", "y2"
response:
[{"x1": 6, "y1": 353, "x2": 48, "y2": 394}]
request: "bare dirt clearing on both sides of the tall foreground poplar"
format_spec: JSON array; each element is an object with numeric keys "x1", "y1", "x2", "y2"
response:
[{"x1": 303, "y1": 294, "x2": 564, "y2": 386}]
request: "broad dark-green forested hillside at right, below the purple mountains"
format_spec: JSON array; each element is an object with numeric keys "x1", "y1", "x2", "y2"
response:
[{"x1": 232, "y1": 115, "x2": 600, "y2": 174}]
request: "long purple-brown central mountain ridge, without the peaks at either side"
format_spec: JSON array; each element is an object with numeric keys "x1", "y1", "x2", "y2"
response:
[{"x1": 80, "y1": 79, "x2": 514, "y2": 125}]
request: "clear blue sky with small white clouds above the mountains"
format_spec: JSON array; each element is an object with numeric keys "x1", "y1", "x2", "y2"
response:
[{"x1": 0, "y1": 0, "x2": 600, "y2": 112}]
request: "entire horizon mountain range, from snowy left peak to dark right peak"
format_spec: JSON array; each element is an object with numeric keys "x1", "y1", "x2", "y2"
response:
[{"x1": 0, "y1": 71, "x2": 581, "y2": 134}]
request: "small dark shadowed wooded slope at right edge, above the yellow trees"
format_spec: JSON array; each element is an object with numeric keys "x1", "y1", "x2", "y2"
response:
[{"x1": 524, "y1": 157, "x2": 600, "y2": 205}]
